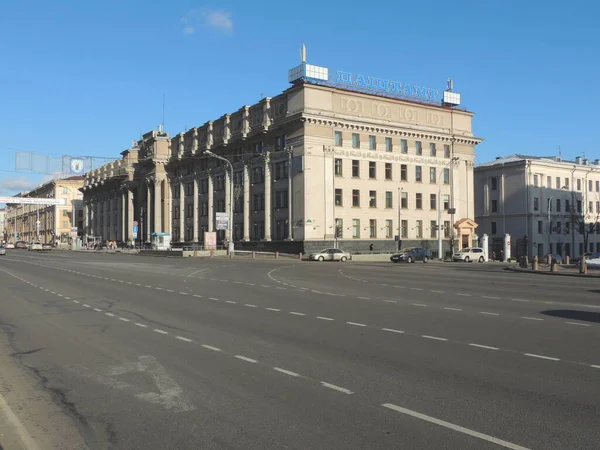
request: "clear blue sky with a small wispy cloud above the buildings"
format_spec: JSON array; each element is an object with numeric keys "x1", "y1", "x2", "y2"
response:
[{"x1": 0, "y1": 0, "x2": 600, "y2": 196}]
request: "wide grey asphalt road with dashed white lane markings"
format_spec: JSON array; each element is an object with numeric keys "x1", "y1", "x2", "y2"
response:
[{"x1": 0, "y1": 251, "x2": 600, "y2": 450}]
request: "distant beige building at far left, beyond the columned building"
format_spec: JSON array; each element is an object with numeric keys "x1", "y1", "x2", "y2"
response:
[{"x1": 5, "y1": 176, "x2": 83, "y2": 245}]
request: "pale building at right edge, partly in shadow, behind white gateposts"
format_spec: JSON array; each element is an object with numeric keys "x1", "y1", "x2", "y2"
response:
[{"x1": 475, "y1": 155, "x2": 600, "y2": 258}]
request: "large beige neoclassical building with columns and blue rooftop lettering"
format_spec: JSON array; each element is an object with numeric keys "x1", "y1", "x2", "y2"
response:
[{"x1": 82, "y1": 59, "x2": 481, "y2": 255}]
